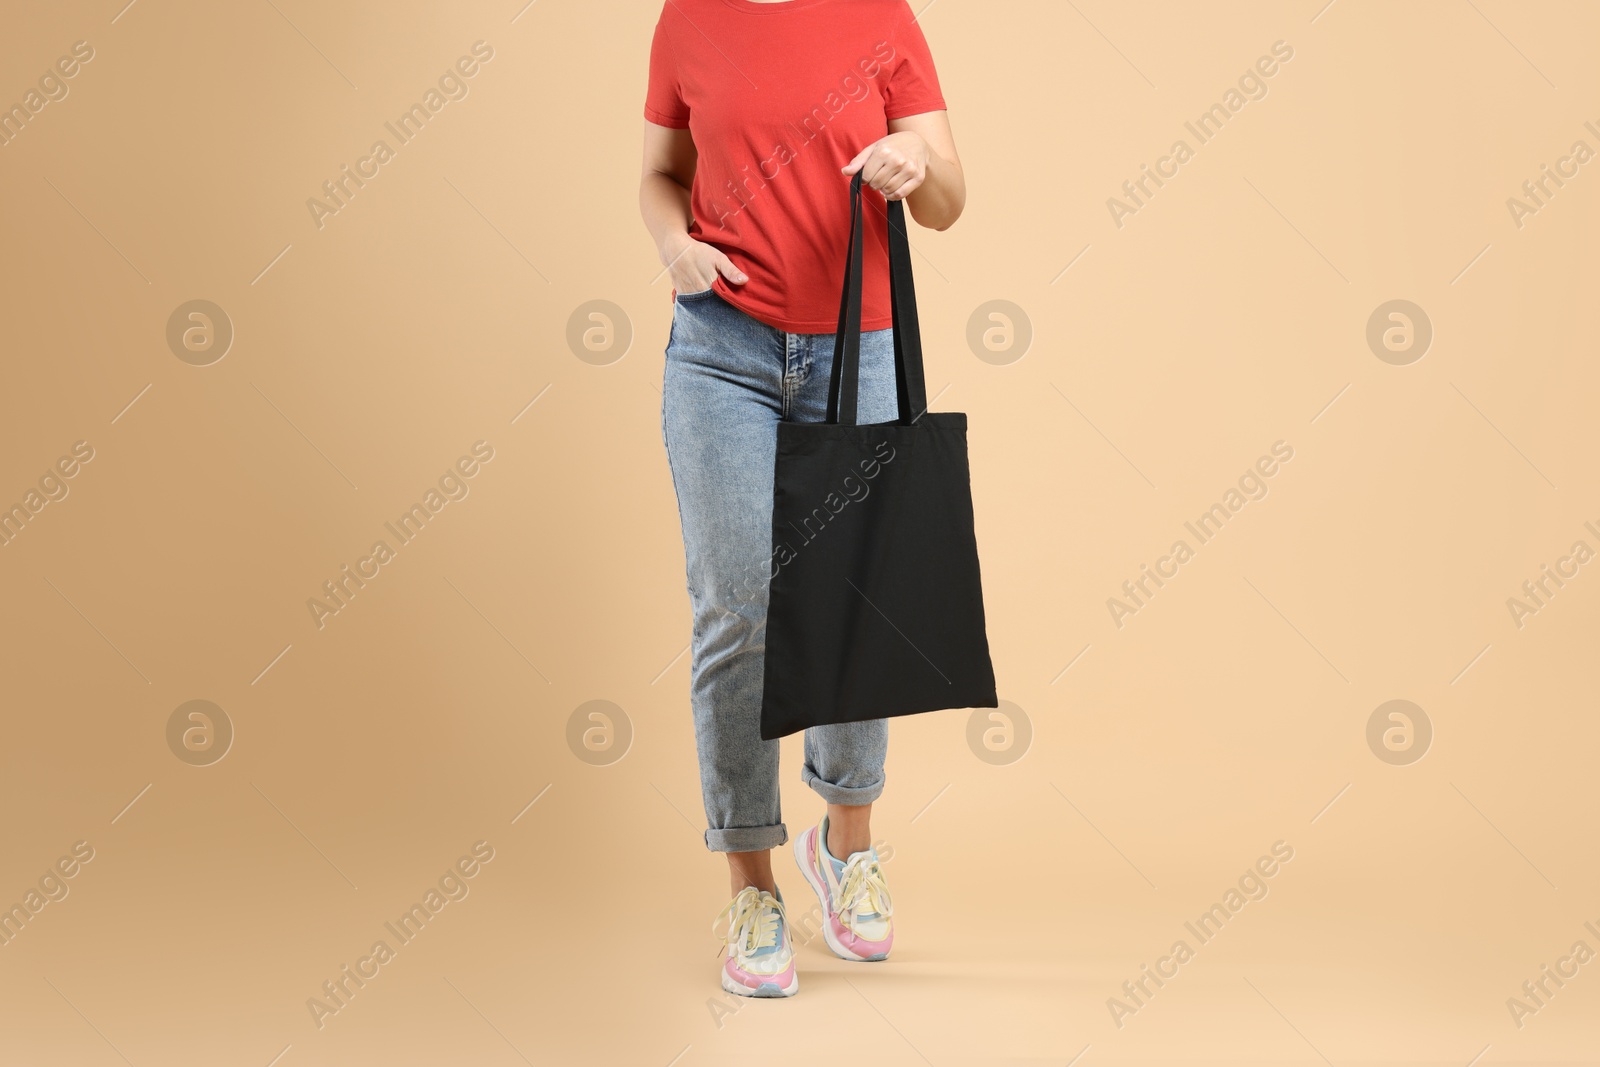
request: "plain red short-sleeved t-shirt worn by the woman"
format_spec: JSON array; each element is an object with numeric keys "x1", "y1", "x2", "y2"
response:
[{"x1": 645, "y1": 0, "x2": 944, "y2": 333}]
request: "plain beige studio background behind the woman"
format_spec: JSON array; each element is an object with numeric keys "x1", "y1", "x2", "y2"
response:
[{"x1": 0, "y1": 0, "x2": 1600, "y2": 1067}]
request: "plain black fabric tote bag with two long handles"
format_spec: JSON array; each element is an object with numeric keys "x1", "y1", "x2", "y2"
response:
[{"x1": 762, "y1": 173, "x2": 1000, "y2": 739}]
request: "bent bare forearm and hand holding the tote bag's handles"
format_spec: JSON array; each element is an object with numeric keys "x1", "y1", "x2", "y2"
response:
[{"x1": 843, "y1": 110, "x2": 966, "y2": 230}]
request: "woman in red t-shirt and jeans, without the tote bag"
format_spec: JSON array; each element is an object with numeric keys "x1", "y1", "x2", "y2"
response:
[{"x1": 638, "y1": 0, "x2": 966, "y2": 997}]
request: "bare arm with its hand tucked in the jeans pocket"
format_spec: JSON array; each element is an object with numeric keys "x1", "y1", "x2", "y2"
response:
[{"x1": 638, "y1": 122, "x2": 747, "y2": 293}]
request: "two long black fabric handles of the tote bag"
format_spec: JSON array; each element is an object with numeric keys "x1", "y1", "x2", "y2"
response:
[{"x1": 827, "y1": 171, "x2": 928, "y2": 426}]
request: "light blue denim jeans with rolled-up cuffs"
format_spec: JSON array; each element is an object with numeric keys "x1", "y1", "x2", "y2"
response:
[{"x1": 661, "y1": 290, "x2": 899, "y2": 853}]
